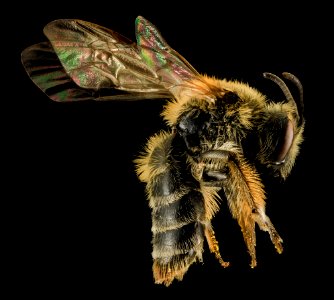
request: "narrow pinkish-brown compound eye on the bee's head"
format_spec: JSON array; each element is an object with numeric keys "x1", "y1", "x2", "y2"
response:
[{"x1": 273, "y1": 120, "x2": 294, "y2": 165}]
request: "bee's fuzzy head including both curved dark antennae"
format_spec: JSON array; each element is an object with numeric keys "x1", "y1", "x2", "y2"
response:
[{"x1": 252, "y1": 73, "x2": 304, "y2": 179}]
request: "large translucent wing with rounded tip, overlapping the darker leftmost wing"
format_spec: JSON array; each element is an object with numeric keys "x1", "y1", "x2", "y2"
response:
[{"x1": 44, "y1": 19, "x2": 172, "y2": 94}]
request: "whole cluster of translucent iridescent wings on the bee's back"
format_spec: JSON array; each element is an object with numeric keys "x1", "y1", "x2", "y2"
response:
[{"x1": 21, "y1": 17, "x2": 202, "y2": 101}]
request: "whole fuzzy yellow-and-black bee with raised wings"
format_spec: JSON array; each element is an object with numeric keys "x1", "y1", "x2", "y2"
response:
[{"x1": 21, "y1": 16, "x2": 305, "y2": 286}]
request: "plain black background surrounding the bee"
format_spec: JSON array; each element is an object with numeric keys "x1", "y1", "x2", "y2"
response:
[{"x1": 9, "y1": 1, "x2": 332, "y2": 299}]
